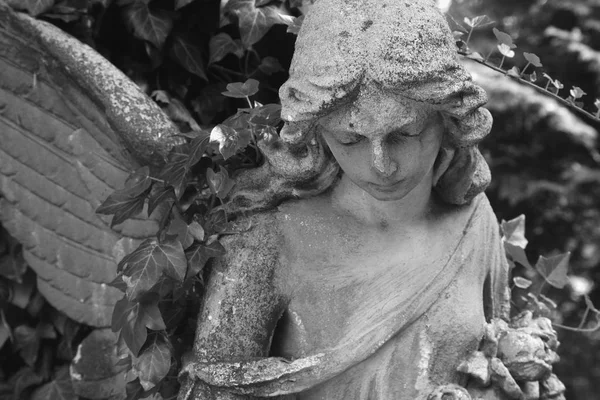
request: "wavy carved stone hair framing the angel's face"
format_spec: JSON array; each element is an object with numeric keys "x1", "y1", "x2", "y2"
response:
[{"x1": 227, "y1": 0, "x2": 492, "y2": 212}]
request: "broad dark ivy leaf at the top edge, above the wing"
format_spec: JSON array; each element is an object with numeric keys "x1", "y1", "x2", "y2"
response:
[{"x1": 125, "y1": 1, "x2": 173, "y2": 49}]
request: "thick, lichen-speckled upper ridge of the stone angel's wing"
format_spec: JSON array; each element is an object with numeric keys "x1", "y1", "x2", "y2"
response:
[{"x1": 0, "y1": 1, "x2": 180, "y2": 164}]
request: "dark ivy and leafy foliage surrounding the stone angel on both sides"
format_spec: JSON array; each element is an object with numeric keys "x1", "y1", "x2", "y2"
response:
[{"x1": 0, "y1": 0, "x2": 600, "y2": 400}]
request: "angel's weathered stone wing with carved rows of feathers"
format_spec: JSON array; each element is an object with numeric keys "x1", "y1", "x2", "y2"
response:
[{"x1": 0, "y1": 0, "x2": 175, "y2": 327}]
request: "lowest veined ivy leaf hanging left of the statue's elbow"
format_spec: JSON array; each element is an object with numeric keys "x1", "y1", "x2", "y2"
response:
[{"x1": 132, "y1": 334, "x2": 171, "y2": 391}]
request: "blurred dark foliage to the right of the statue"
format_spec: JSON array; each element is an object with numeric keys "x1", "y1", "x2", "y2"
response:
[{"x1": 450, "y1": 0, "x2": 600, "y2": 400}]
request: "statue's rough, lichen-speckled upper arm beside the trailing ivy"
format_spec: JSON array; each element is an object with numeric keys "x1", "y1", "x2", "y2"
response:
[{"x1": 183, "y1": 215, "x2": 287, "y2": 399}]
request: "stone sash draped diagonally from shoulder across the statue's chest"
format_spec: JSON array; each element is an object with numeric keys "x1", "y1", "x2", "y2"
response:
[{"x1": 184, "y1": 196, "x2": 502, "y2": 396}]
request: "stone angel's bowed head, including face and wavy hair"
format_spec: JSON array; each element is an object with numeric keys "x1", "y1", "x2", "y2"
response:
[{"x1": 280, "y1": 0, "x2": 492, "y2": 204}]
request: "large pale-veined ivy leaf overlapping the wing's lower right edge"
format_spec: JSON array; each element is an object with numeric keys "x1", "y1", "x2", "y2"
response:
[{"x1": 119, "y1": 239, "x2": 187, "y2": 299}]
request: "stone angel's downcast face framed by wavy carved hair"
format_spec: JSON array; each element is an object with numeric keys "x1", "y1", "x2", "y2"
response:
[{"x1": 315, "y1": 88, "x2": 444, "y2": 200}]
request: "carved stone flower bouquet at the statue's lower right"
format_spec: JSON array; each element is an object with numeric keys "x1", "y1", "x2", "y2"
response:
[{"x1": 458, "y1": 311, "x2": 565, "y2": 400}]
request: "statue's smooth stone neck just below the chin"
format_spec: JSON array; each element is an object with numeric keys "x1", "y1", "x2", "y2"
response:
[{"x1": 332, "y1": 173, "x2": 434, "y2": 228}]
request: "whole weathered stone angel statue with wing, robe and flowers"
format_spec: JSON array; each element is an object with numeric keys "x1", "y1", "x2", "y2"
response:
[{"x1": 0, "y1": 0, "x2": 564, "y2": 400}]
